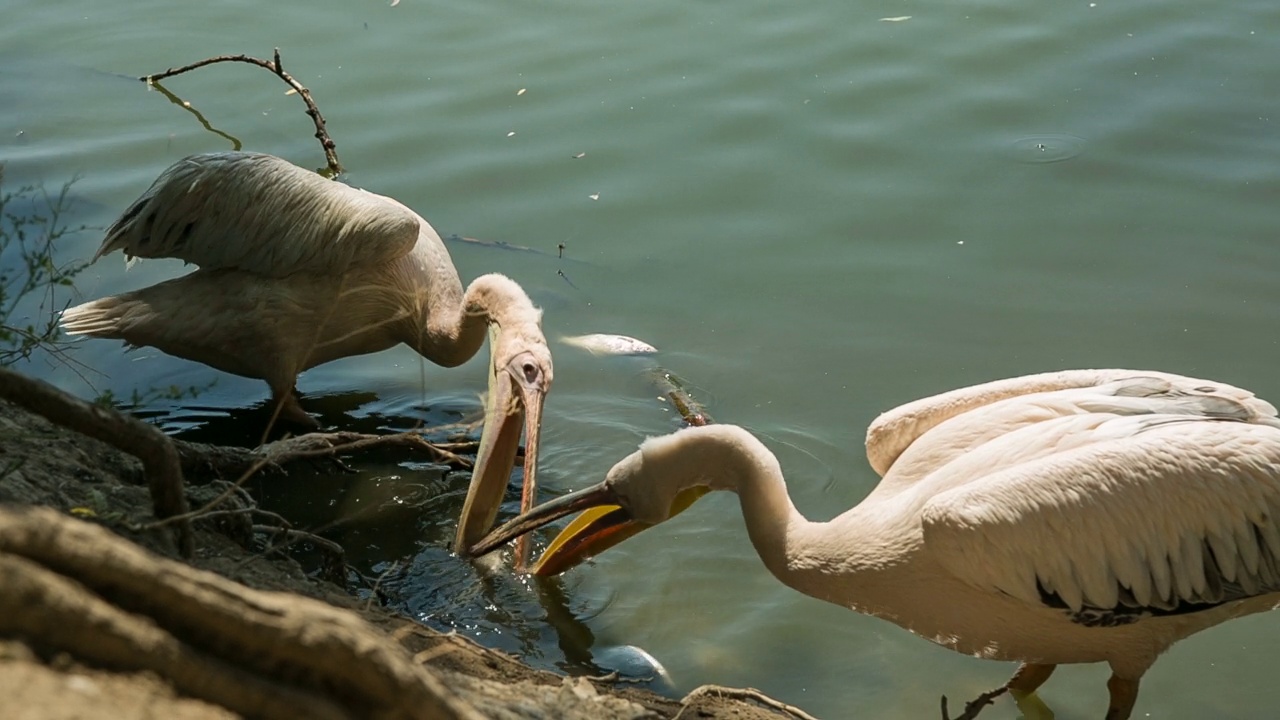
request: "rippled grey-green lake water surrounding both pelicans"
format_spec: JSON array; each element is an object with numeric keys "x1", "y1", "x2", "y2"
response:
[{"x1": 0, "y1": 0, "x2": 1280, "y2": 720}]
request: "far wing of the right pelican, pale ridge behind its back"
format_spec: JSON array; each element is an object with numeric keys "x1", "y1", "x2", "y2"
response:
[{"x1": 867, "y1": 369, "x2": 1276, "y2": 475}]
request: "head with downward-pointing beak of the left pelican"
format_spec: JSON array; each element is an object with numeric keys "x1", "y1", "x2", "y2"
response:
[{"x1": 454, "y1": 316, "x2": 552, "y2": 569}]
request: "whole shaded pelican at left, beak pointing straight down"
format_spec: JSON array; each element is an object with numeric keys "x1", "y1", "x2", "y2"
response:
[{"x1": 61, "y1": 152, "x2": 552, "y2": 556}]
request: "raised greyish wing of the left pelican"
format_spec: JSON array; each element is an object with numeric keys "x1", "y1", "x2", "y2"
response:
[{"x1": 93, "y1": 152, "x2": 421, "y2": 278}]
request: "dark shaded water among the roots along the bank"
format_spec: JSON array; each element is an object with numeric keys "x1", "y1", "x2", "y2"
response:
[{"x1": 162, "y1": 392, "x2": 671, "y2": 692}]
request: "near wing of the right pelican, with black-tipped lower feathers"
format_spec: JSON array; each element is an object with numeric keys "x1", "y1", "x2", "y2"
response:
[{"x1": 922, "y1": 414, "x2": 1280, "y2": 614}]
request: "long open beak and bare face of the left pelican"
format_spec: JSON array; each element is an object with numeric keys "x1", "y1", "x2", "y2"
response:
[{"x1": 453, "y1": 335, "x2": 548, "y2": 570}]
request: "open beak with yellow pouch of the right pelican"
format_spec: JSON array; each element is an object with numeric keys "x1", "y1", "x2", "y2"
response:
[{"x1": 470, "y1": 482, "x2": 710, "y2": 577}]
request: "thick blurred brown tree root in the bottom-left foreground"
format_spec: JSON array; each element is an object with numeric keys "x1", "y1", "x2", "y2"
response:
[{"x1": 0, "y1": 507, "x2": 483, "y2": 720}]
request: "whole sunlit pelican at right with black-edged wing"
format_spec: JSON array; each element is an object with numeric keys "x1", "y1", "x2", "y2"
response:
[{"x1": 471, "y1": 370, "x2": 1280, "y2": 720}]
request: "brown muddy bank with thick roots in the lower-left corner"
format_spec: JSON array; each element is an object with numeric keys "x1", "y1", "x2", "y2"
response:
[{"x1": 0, "y1": 401, "x2": 814, "y2": 720}]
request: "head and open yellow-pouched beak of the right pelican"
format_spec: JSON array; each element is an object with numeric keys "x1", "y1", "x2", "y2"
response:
[{"x1": 470, "y1": 425, "x2": 755, "y2": 575}]
